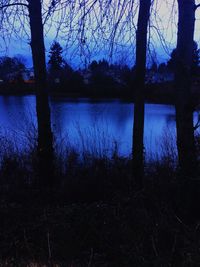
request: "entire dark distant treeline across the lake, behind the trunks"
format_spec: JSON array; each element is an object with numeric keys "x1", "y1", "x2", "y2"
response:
[{"x1": 0, "y1": 42, "x2": 200, "y2": 102}]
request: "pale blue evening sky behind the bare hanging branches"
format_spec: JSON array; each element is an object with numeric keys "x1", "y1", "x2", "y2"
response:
[{"x1": 0, "y1": 0, "x2": 200, "y2": 68}]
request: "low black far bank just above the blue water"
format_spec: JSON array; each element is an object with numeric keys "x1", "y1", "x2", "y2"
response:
[{"x1": 0, "y1": 83, "x2": 192, "y2": 104}]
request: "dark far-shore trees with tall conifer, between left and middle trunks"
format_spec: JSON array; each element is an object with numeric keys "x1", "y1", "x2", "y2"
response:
[{"x1": 48, "y1": 41, "x2": 133, "y2": 95}]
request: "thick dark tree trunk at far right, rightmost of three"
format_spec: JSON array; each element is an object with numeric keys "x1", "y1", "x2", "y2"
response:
[{"x1": 175, "y1": 0, "x2": 197, "y2": 178}]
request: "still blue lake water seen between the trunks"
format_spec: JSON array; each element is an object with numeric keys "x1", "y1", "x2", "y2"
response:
[{"x1": 0, "y1": 96, "x2": 175, "y2": 158}]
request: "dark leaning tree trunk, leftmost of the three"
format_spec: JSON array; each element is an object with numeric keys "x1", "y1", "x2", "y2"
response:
[{"x1": 29, "y1": 0, "x2": 54, "y2": 185}]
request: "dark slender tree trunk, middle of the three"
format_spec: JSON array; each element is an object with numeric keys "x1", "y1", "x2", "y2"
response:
[{"x1": 132, "y1": 0, "x2": 151, "y2": 188}]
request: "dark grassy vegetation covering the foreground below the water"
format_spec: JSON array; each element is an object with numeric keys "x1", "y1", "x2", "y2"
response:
[{"x1": 0, "y1": 136, "x2": 200, "y2": 267}]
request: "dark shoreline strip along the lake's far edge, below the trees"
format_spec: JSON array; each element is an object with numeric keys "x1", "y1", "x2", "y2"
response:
[{"x1": 0, "y1": 83, "x2": 200, "y2": 105}]
